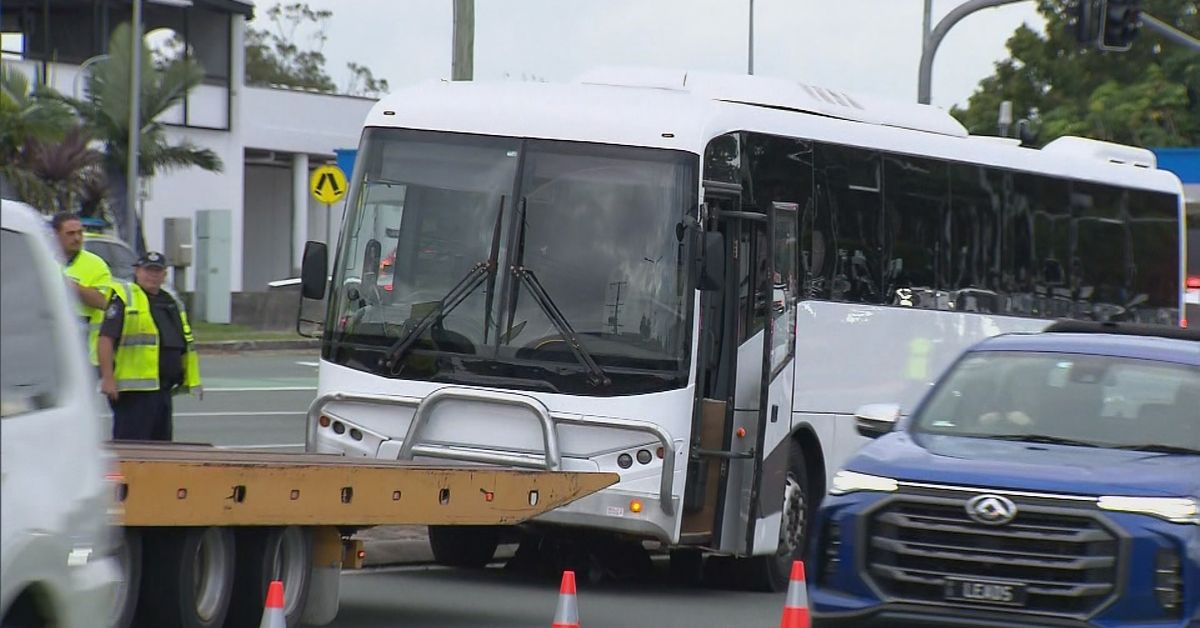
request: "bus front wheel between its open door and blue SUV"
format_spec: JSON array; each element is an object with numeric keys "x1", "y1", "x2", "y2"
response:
[{"x1": 740, "y1": 441, "x2": 812, "y2": 592}]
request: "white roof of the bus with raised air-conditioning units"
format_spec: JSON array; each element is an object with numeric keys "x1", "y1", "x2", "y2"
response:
[{"x1": 366, "y1": 68, "x2": 1182, "y2": 196}]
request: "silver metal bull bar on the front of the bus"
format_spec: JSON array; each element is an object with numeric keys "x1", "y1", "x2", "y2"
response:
[{"x1": 306, "y1": 387, "x2": 676, "y2": 515}]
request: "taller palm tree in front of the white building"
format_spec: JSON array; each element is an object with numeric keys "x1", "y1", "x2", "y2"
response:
[{"x1": 60, "y1": 24, "x2": 222, "y2": 253}]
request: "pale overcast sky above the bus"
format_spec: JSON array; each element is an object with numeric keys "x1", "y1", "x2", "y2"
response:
[{"x1": 252, "y1": 0, "x2": 1044, "y2": 108}]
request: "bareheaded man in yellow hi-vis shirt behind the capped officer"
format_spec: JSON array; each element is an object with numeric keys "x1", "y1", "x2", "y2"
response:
[{"x1": 50, "y1": 211, "x2": 113, "y2": 366}]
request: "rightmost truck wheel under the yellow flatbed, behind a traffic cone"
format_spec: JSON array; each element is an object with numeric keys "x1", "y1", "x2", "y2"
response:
[{"x1": 226, "y1": 526, "x2": 312, "y2": 628}]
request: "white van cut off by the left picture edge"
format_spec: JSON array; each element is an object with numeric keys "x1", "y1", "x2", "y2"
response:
[{"x1": 0, "y1": 201, "x2": 119, "y2": 628}]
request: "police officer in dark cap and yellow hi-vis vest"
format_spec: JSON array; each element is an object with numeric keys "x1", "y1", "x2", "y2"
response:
[{"x1": 98, "y1": 251, "x2": 200, "y2": 441}]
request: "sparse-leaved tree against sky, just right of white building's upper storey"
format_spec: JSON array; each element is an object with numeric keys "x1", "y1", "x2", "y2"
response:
[{"x1": 246, "y1": 2, "x2": 337, "y2": 92}]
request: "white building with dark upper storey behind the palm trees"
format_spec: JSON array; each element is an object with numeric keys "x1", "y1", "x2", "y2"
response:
[{"x1": 0, "y1": 0, "x2": 374, "y2": 292}]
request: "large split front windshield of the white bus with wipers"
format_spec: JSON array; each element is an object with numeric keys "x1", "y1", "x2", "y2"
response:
[{"x1": 325, "y1": 128, "x2": 698, "y2": 395}]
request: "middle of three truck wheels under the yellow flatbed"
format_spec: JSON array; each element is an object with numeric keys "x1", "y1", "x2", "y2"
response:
[{"x1": 137, "y1": 527, "x2": 236, "y2": 628}]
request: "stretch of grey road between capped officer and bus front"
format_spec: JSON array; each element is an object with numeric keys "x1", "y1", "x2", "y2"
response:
[{"x1": 175, "y1": 351, "x2": 318, "y2": 451}]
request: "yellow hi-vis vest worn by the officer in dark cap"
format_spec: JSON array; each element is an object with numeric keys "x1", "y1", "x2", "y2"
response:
[{"x1": 113, "y1": 282, "x2": 200, "y2": 391}]
